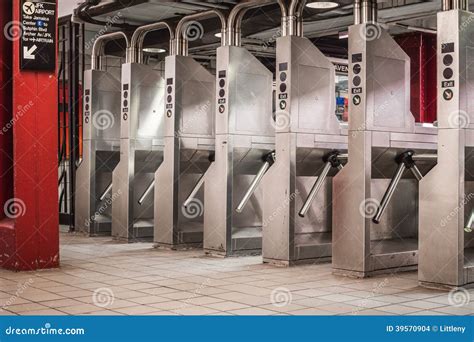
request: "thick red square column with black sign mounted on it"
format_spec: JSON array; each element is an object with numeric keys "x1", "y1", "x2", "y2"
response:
[{"x1": 0, "y1": 0, "x2": 59, "y2": 270}]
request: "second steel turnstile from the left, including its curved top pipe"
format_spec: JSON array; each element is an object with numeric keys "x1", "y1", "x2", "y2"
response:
[{"x1": 111, "y1": 23, "x2": 173, "y2": 242}]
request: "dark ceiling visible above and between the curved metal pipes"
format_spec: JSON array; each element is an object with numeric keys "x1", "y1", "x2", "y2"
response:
[{"x1": 74, "y1": 0, "x2": 456, "y2": 62}]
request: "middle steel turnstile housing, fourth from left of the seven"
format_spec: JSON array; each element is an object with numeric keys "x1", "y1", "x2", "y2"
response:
[{"x1": 204, "y1": 46, "x2": 275, "y2": 256}]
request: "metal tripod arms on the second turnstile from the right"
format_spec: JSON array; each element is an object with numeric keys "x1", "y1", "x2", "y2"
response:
[{"x1": 372, "y1": 151, "x2": 436, "y2": 224}]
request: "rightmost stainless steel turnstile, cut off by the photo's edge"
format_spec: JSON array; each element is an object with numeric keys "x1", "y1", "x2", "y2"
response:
[{"x1": 418, "y1": 7, "x2": 474, "y2": 287}]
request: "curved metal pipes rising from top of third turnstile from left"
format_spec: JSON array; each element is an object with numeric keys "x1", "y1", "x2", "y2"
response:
[{"x1": 175, "y1": 9, "x2": 228, "y2": 56}]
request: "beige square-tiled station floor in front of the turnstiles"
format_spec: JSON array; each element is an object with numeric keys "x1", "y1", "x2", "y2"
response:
[{"x1": 0, "y1": 234, "x2": 474, "y2": 315}]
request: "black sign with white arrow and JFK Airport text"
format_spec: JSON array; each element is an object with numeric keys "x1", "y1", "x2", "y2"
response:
[{"x1": 20, "y1": 0, "x2": 57, "y2": 71}]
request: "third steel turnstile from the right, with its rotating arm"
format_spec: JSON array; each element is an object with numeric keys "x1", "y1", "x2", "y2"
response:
[{"x1": 262, "y1": 32, "x2": 347, "y2": 265}]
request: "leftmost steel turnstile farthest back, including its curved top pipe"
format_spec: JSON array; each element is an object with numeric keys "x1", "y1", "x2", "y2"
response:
[{"x1": 75, "y1": 32, "x2": 129, "y2": 236}]
